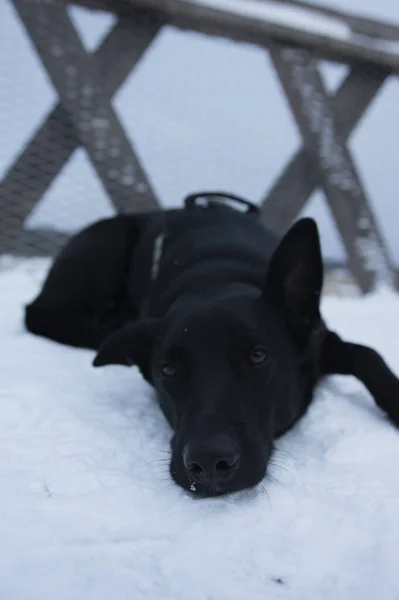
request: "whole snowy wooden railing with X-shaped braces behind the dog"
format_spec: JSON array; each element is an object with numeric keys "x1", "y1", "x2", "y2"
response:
[{"x1": 0, "y1": 0, "x2": 399, "y2": 292}]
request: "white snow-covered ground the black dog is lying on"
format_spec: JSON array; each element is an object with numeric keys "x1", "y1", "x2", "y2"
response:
[{"x1": 0, "y1": 259, "x2": 399, "y2": 600}]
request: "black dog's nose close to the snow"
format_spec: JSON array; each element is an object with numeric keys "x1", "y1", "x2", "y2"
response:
[{"x1": 183, "y1": 436, "x2": 240, "y2": 484}]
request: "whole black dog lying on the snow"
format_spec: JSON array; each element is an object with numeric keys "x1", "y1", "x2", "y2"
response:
[{"x1": 26, "y1": 198, "x2": 399, "y2": 496}]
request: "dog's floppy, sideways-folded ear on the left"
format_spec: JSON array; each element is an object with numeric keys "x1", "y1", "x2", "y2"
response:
[{"x1": 93, "y1": 319, "x2": 159, "y2": 379}]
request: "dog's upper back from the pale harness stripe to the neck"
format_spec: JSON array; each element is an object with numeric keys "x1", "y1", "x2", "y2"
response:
[{"x1": 127, "y1": 206, "x2": 277, "y2": 316}]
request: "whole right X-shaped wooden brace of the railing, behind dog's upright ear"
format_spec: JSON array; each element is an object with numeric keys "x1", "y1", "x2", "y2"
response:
[{"x1": 262, "y1": 43, "x2": 398, "y2": 292}]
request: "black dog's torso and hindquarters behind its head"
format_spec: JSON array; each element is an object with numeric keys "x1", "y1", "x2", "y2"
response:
[{"x1": 25, "y1": 205, "x2": 276, "y2": 348}]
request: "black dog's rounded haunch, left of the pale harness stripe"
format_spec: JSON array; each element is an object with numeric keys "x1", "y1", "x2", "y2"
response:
[{"x1": 25, "y1": 216, "x2": 142, "y2": 349}]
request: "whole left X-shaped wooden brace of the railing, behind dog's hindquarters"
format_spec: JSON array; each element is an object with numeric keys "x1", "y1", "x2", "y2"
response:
[{"x1": 0, "y1": 0, "x2": 162, "y2": 253}]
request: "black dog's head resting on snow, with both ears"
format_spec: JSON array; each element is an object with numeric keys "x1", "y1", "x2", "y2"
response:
[{"x1": 94, "y1": 219, "x2": 323, "y2": 496}]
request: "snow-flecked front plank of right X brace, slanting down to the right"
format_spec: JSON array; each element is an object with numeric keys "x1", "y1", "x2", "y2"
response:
[{"x1": 271, "y1": 44, "x2": 396, "y2": 292}]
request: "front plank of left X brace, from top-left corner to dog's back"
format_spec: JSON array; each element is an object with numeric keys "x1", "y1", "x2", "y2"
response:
[{"x1": 13, "y1": 0, "x2": 158, "y2": 212}]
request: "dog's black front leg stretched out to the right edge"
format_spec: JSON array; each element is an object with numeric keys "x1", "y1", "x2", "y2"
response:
[{"x1": 321, "y1": 332, "x2": 399, "y2": 427}]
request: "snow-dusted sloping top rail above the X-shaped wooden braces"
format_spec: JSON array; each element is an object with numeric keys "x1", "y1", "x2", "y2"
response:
[{"x1": 78, "y1": 0, "x2": 399, "y2": 72}]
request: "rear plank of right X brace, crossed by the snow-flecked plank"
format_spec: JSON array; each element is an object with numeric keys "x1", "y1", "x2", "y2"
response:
[{"x1": 261, "y1": 65, "x2": 390, "y2": 234}]
